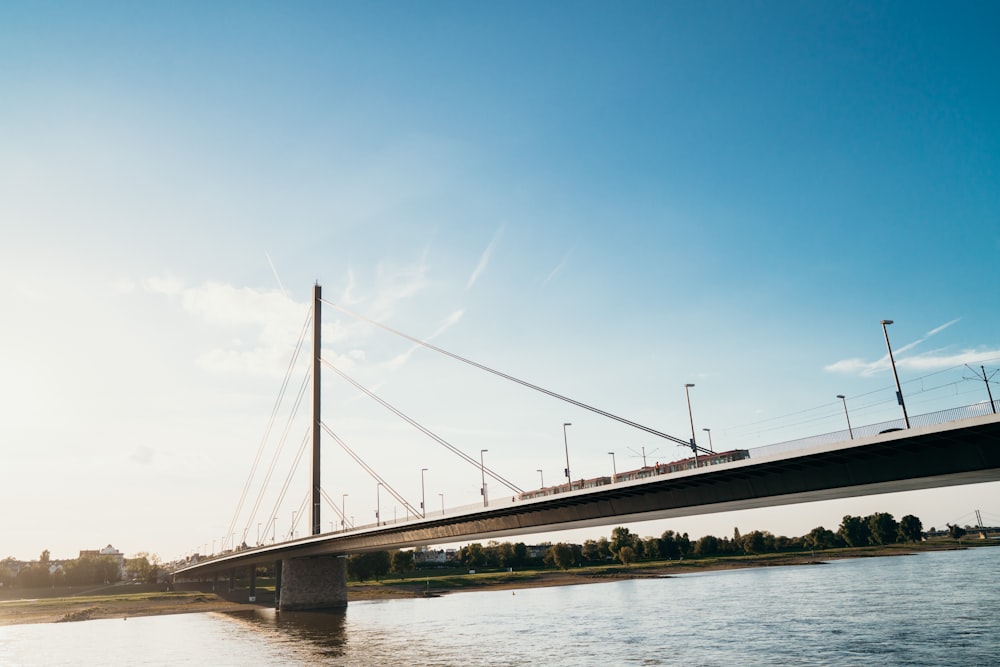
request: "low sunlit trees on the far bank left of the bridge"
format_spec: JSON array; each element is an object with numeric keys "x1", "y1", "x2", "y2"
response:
[{"x1": 0, "y1": 550, "x2": 160, "y2": 588}]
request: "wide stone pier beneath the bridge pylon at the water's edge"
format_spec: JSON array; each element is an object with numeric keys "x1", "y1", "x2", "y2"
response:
[{"x1": 278, "y1": 556, "x2": 347, "y2": 610}]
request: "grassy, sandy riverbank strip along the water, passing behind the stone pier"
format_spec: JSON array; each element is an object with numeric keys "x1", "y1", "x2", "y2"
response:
[{"x1": 0, "y1": 540, "x2": 997, "y2": 625}]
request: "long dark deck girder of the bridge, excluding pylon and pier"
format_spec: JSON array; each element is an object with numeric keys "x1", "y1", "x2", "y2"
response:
[{"x1": 178, "y1": 417, "x2": 1000, "y2": 612}]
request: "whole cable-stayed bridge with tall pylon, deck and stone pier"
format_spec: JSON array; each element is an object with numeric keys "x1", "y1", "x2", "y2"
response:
[{"x1": 174, "y1": 286, "x2": 1000, "y2": 609}]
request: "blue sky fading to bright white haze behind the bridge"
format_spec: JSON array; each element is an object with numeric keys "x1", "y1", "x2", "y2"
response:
[{"x1": 0, "y1": 0, "x2": 1000, "y2": 560}]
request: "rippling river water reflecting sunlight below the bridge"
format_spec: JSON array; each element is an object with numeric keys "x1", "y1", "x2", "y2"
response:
[{"x1": 0, "y1": 548, "x2": 1000, "y2": 667}]
